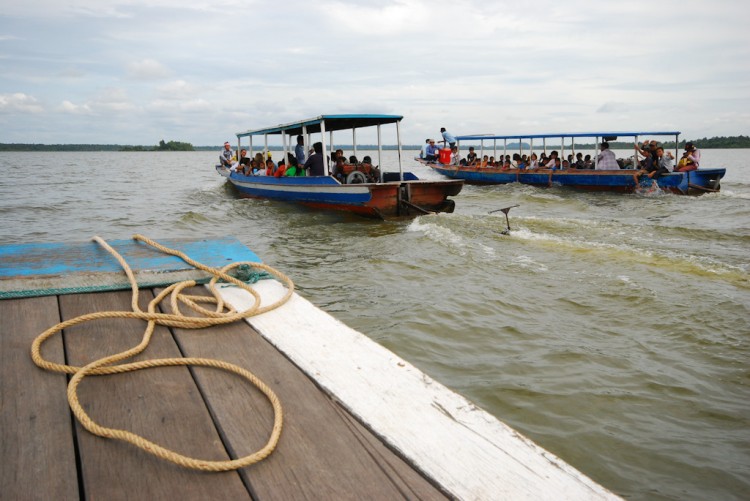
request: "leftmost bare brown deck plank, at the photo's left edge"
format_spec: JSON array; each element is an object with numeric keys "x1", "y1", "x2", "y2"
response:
[{"x1": 0, "y1": 296, "x2": 78, "y2": 500}]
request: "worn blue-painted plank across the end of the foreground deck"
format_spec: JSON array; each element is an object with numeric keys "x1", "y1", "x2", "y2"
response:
[{"x1": 0, "y1": 237, "x2": 260, "y2": 299}]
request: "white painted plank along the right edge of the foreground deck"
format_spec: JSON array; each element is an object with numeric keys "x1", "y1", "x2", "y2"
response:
[{"x1": 216, "y1": 280, "x2": 620, "y2": 501}]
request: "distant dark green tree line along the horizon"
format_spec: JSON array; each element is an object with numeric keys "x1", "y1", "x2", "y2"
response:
[{"x1": 0, "y1": 135, "x2": 750, "y2": 151}]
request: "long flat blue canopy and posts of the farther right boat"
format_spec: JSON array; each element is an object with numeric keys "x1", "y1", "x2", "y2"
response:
[{"x1": 456, "y1": 131, "x2": 681, "y2": 170}]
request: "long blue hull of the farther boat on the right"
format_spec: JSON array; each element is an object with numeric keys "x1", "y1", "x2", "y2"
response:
[{"x1": 421, "y1": 161, "x2": 726, "y2": 195}]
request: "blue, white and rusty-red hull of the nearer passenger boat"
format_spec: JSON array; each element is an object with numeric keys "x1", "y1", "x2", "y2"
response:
[{"x1": 216, "y1": 166, "x2": 463, "y2": 219}]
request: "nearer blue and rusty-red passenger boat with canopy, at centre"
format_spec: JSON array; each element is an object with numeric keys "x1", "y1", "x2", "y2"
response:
[{"x1": 216, "y1": 114, "x2": 463, "y2": 219}]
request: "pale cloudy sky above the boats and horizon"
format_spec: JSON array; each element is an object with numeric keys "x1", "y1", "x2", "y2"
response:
[{"x1": 0, "y1": 0, "x2": 750, "y2": 146}]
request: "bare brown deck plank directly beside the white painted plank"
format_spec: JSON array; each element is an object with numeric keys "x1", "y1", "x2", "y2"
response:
[{"x1": 162, "y1": 288, "x2": 445, "y2": 499}]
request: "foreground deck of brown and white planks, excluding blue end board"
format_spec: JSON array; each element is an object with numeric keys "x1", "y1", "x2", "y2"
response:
[{"x1": 0, "y1": 236, "x2": 617, "y2": 500}]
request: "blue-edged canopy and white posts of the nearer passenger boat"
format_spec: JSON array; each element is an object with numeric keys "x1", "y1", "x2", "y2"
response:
[{"x1": 235, "y1": 114, "x2": 404, "y2": 182}]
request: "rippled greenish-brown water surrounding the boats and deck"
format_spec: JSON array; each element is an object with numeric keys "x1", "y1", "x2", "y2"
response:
[{"x1": 0, "y1": 150, "x2": 750, "y2": 500}]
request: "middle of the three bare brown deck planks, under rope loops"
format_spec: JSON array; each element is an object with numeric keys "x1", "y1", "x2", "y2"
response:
[{"x1": 60, "y1": 291, "x2": 249, "y2": 500}]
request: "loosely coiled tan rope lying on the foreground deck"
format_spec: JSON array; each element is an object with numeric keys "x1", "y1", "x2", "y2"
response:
[{"x1": 31, "y1": 235, "x2": 294, "y2": 471}]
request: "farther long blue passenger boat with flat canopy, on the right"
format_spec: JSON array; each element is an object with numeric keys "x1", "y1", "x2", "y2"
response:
[{"x1": 417, "y1": 131, "x2": 726, "y2": 195}]
